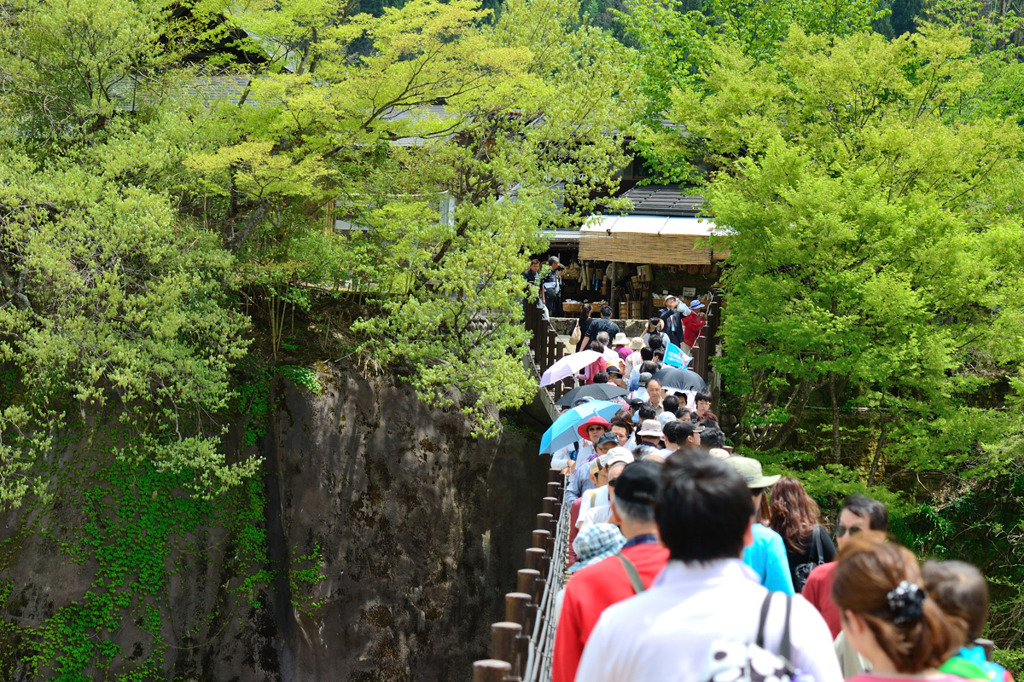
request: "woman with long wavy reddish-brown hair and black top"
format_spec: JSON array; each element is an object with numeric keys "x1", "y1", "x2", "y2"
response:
[{"x1": 769, "y1": 476, "x2": 836, "y2": 594}]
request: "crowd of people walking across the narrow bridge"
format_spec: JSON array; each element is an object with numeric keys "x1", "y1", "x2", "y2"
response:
[{"x1": 552, "y1": 385, "x2": 1012, "y2": 682}]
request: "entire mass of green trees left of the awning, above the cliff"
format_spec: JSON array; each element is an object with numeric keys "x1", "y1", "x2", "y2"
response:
[{"x1": 0, "y1": 0, "x2": 636, "y2": 509}]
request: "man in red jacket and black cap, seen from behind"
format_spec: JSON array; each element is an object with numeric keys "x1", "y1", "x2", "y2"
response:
[{"x1": 552, "y1": 461, "x2": 669, "y2": 682}]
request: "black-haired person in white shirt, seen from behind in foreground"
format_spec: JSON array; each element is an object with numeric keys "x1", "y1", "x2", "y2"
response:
[{"x1": 575, "y1": 449, "x2": 843, "y2": 682}]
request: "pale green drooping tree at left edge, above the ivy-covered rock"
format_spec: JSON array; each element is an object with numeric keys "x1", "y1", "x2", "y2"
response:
[{"x1": 0, "y1": 156, "x2": 251, "y2": 503}]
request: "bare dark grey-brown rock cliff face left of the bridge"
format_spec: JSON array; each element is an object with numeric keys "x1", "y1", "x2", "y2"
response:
[{"x1": 0, "y1": 369, "x2": 547, "y2": 682}]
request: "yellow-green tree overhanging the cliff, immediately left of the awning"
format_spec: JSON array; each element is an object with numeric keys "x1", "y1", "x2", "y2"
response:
[{"x1": 180, "y1": 0, "x2": 633, "y2": 431}]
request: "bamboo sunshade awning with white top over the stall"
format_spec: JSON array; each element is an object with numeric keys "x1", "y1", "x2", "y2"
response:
[{"x1": 580, "y1": 215, "x2": 728, "y2": 265}]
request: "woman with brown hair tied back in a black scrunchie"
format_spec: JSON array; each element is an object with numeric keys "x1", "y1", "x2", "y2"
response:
[{"x1": 833, "y1": 538, "x2": 964, "y2": 682}]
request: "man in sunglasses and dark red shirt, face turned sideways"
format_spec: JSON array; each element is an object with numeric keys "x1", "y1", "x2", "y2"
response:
[{"x1": 800, "y1": 495, "x2": 889, "y2": 638}]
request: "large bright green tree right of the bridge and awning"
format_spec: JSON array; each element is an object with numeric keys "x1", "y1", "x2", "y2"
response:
[{"x1": 672, "y1": 28, "x2": 1024, "y2": 473}]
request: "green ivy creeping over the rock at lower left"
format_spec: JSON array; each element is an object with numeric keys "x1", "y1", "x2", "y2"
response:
[{"x1": 0, "y1": 446, "x2": 269, "y2": 682}]
